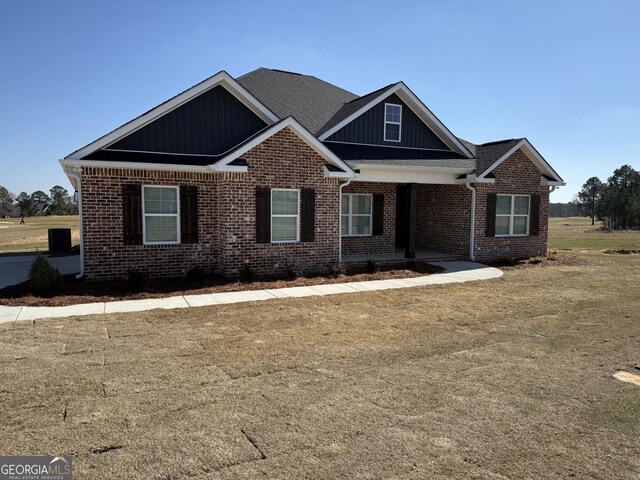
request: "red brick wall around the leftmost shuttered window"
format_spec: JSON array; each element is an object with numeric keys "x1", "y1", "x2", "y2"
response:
[{"x1": 82, "y1": 167, "x2": 220, "y2": 280}]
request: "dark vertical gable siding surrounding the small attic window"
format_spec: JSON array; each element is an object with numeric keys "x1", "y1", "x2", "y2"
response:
[{"x1": 326, "y1": 94, "x2": 450, "y2": 150}]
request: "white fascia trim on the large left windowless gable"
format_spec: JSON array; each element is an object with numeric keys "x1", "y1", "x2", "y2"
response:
[{"x1": 66, "y1": 70, "x2": 279, "y2": 160}]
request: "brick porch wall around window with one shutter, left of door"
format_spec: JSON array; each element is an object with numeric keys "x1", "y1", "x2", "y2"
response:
[{"x1": 342, "y1": 182, "x2": 396, "y2": 255}]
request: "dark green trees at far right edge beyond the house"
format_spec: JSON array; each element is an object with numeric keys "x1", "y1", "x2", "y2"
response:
[{"x1": 578, "y1": 165, "x2": 640, "y2": 230}]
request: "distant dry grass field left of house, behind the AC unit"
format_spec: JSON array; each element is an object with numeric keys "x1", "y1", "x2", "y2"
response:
[{"x1": 0, "y1": 215, "x2": 80, "y2": 253}]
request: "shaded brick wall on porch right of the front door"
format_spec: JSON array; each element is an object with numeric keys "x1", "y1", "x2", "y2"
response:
[{"x1": 416, "y1": 185, "x2": 471, "y2": 257}]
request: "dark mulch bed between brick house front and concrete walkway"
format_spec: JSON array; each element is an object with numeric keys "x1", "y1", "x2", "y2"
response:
[{"x1": 0, "y1": 262, "x2": 443, "y2": 307}]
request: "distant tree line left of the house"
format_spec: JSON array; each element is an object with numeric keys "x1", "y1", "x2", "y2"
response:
[{"x1": 0, "y1": 185, "x2": 78, "y2": 217}]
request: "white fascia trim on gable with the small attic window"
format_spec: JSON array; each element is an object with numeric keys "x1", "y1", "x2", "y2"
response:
[{"x1": 318, "y1": 82, "x2": 474, "y2": 158}]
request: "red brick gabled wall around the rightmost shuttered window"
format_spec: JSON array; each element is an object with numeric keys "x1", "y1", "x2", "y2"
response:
[{"x1": 475, "y1": 150, "x2": 549, "y2": 261}]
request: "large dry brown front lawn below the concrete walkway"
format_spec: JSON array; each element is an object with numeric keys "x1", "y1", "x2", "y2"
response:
[{"x1": 0, "y1": 219, "x2": 640, "y2": 479}]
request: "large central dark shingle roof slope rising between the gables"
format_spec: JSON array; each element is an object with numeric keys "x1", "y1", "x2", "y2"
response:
[{"x1": 236, "y1": 68, "x2": 358, "y2": 135}]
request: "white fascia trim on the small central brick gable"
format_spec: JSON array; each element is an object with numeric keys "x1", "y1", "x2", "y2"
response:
[{"x1": 214, "y1": 117, "x2": 355, "y2": 178}]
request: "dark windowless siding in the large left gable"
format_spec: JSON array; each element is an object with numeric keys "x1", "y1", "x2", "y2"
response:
[{"x1": 103, "y1": 86, "x2": 266, "y2": 155}]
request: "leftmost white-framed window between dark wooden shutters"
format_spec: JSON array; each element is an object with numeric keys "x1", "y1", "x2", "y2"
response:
[{"x1": 142, "y1": 186, "x2": 180, "y2": 245}]
